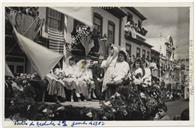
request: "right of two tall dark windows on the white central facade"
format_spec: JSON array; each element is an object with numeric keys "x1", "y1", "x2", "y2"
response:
[{"x1": 108, "y1": 21, "x2": 115, "y2": 44}]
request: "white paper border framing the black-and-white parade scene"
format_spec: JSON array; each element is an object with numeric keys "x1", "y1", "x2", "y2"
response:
[{"x1": 0, "y1": 1, "x2": 195, "y2": 128}]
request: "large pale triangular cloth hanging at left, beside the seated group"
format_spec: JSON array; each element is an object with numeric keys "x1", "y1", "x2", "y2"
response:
[{"x1": 14, "y1": 28, "x2": 63, "y2": 78}]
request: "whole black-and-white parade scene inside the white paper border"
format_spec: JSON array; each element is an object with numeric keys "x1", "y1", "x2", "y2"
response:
[{"x1": 4, "y1": 6, "x2": 190, "y2": 121}]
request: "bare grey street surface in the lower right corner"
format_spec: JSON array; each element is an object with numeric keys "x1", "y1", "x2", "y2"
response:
[{"x1": 166, "y1": 99, "x2": 189, "y2": 119}]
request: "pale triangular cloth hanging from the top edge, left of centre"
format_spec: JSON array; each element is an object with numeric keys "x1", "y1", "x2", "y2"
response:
[{"x1": 51, "y1": 7, "x2": 93, "y2": 26}]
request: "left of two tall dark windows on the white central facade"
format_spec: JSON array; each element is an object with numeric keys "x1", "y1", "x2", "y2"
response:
[{"x1": 93, "y1": 13, "x2": 102, "y2": 35}]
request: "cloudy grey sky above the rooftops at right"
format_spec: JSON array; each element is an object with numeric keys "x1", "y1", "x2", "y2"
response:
[{"x1": 136, "y1": 7, "x2": 189, "y2": 59}]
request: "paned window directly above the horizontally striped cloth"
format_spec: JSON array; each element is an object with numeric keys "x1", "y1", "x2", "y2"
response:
[{"x1": 47, "y1": 8, "x2": 64, "y2": 31}]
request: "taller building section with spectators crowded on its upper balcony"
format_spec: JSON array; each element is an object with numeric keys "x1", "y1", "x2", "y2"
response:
[{"x1": 124, "y1": 7, "x2": 152, "y2": 60}]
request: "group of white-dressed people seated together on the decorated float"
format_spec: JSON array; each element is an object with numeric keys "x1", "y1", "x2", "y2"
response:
[{"x1": 46, "y1": 46, "x2": 159, "y2": 101}]
